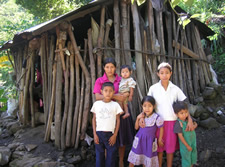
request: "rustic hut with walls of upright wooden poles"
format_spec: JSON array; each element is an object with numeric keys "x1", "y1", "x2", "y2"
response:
[{"x1": 1, "y1": 0, "x2": 213, "y2": 149}]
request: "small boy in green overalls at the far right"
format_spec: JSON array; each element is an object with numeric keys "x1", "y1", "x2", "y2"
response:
[{"x1": 173, "y1": 101, "x2": 197, "y2": 167}]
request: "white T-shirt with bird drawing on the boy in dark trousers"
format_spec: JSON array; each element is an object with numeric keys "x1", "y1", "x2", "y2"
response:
[{"x1": 91, "y1": 100, "x2": 123, "y2": 133}]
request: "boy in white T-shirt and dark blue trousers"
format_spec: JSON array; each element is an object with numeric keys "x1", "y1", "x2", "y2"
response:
[{"x1": 91, "y1": 82, "x2": 123, "y2": 167}]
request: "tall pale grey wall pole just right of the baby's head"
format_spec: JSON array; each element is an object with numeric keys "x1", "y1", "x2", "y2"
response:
[{"x1": 131, "y1": 2, "x2": 146, "y2": 95}]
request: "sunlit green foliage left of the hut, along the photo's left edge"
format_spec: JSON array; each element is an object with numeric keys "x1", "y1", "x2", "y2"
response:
[{"x1": 0, "y1": 0, "x2": 40, "y2": 111}]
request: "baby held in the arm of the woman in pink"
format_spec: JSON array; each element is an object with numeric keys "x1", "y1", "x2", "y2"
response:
[{"x1": 119, "y1": 65, "x2": 136, "y2": 119}]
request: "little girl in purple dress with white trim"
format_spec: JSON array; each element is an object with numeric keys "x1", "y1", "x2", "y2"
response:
[{"x1": 128, "y1": 96, "x2": 163, "y2": 167}]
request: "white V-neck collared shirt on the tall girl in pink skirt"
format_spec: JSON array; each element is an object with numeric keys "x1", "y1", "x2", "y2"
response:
[{"x1": 148, "y1": 81, "x2": 186, "y2": 121}]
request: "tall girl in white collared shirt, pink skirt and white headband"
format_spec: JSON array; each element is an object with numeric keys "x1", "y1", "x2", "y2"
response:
[{"x1": 148, "y1": 62, "x2": 193, "y2": 167}]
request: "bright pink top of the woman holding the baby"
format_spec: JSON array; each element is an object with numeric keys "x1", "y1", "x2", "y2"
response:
[{"x1": 93, "y1": 73, "x2": 121, "y2": 94}]
